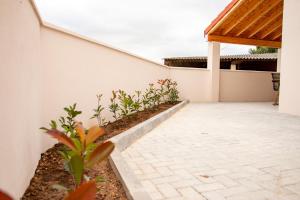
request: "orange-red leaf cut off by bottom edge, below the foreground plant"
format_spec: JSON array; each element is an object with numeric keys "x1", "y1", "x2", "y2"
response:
[{"x1": 65, "y1": 181, "x2": 97, "y2": 200}]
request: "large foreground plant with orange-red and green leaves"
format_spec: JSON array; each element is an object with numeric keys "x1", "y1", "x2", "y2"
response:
[{"x1": 46, "y1": 123, "x2": 114, "y2": 187}]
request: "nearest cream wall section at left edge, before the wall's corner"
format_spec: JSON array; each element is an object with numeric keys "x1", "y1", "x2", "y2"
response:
[{"x1": 0, "y1": 0, "x2": 41, "y2": 199}]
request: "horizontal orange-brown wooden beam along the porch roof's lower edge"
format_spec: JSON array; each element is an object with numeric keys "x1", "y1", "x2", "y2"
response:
[{"x1": 208, "y1": 35, "x2": 281, "y2": 48}]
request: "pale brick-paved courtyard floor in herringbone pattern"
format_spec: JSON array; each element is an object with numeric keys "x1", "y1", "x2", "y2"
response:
[{"x1": 122, "y1": 103, "x2": 300, "y2": 200}]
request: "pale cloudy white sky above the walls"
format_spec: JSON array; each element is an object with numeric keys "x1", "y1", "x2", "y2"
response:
[{"x1": 36, "y1": 0, "x2": 251, "y2": 63}]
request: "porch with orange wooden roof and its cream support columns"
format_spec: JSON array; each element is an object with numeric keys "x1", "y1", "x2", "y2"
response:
[{"x1": 204, "y1": 0, "x2": 283, "y2": 102}]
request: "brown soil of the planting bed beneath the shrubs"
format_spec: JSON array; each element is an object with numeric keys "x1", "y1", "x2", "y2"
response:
[{"x1": 22, "y1": 104, "x2": 179, "y2": 200}]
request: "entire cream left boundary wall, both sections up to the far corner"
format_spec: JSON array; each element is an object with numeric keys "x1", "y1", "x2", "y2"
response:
[{"x1": 0, "y1": 0, "x2": 169, "y2": 199}]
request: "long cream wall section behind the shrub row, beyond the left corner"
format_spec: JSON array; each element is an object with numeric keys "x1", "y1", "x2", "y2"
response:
[{"x1": 41, "y1": 27, "x2": 169, "y2": 147}]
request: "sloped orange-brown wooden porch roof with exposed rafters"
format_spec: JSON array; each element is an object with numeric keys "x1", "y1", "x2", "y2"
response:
[{"x1": 204, "y1": 0, "x2": 283, "y2": 48}]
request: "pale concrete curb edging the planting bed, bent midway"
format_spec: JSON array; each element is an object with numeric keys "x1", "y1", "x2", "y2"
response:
[{"x1": 109, "y1": 101, "x2": 189, "y2": 200}]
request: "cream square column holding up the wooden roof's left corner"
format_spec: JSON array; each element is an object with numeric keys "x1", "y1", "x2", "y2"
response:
[{"x1": 207, "y1": 42, "x2": 220, "y2": 102}]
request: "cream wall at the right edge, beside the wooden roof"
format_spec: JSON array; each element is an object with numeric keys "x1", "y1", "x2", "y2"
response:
[{"x1": 279, "y1": 0, "x2": 300, "y2": 115}]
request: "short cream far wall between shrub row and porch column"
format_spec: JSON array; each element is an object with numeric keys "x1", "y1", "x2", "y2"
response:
[{"x1": 170, "y1": 67, "x2": 211, "y2": 102}]
